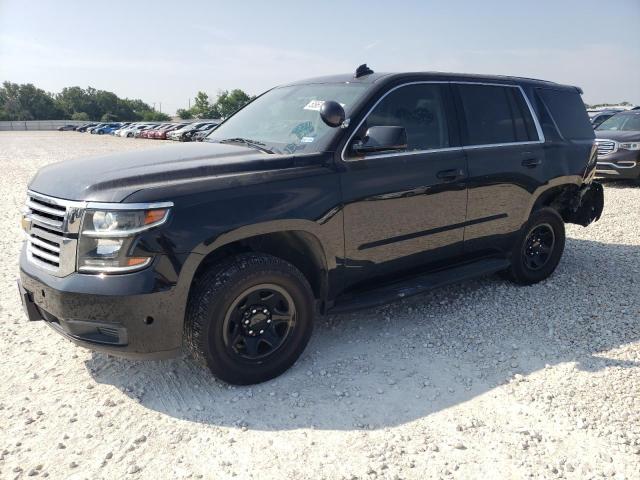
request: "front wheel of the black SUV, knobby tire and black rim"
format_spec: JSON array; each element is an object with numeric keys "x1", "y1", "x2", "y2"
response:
[{"x1": 185, "y1": 253, "x2": 314, "y2": 385}]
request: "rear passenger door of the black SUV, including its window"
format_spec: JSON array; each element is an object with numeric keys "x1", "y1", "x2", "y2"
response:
[{"x1": 454, "y1": 83, "x2": 548, "y2": 256}]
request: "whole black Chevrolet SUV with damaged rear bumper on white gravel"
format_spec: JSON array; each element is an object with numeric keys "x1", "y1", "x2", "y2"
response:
[{"x1": 20, "y1": 66, "x2": 603, "y2": 384}]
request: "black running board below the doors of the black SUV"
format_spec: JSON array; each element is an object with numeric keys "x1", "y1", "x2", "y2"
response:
[{"x1": 327, "y1": 258, "x2": 510, "y2": 314}]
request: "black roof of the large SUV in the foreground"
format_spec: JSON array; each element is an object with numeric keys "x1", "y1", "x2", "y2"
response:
[{"x1": 288, "y1": 72, "x2": 577, "y2": 89}]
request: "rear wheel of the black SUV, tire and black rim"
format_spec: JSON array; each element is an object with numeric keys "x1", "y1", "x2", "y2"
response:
[{"x1": 504, "y1": 208, "x2": 565, "y2": 285}]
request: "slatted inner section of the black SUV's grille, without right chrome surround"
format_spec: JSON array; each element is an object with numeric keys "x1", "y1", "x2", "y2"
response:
[{"x1": 27, "y1": 195, "x2": 67, "y2": 270}]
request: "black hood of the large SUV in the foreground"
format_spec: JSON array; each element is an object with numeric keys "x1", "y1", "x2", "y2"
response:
[{"x1": 29, "y1": 142, "x2": 304, "y2": 202}]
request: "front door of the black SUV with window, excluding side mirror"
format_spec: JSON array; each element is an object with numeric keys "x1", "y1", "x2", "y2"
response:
[{"x1": 341, "y1": 82, "x2": 467, "y2": 287}]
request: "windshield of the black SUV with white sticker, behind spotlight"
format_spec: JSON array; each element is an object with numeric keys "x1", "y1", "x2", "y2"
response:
[{"x1": 206, "y1": 83, "x2": 368, "y2": 153}]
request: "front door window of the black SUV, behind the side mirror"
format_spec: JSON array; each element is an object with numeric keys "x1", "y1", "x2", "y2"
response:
[{"x1": 355, "y1": 84, "x2": 449, "y2": 150}]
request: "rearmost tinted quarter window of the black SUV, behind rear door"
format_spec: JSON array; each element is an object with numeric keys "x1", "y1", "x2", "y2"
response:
[{"x1": 538, "y1": 88, "x2": 595, "y2": 140}]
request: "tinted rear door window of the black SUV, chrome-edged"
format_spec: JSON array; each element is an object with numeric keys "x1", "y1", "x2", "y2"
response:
[{"x1": 458, "y1": 84, "x2": 538, "y2": 145}]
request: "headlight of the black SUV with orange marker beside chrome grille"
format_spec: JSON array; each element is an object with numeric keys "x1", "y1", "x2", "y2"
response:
[{"x1": 78, "y1": 204, "x2": 171, "y2": 273}]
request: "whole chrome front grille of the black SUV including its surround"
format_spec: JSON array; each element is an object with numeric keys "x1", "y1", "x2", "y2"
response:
[{"x1": 25, "y1": 192, "x2": 84, "y2": 277}]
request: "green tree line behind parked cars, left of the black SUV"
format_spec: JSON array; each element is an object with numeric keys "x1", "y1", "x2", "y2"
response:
[{"x1": 0, "y1": 81, "x2": 253, "y2": 122}]
